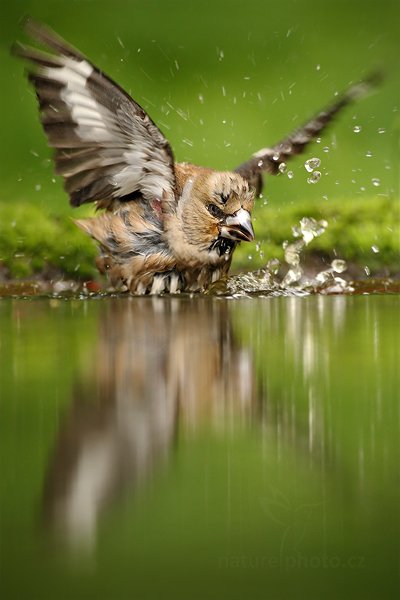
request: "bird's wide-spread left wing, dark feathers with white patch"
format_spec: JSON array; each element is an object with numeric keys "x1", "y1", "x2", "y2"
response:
[{"x1": 13, "y1": 19, "x2": 175, "y2": 206}]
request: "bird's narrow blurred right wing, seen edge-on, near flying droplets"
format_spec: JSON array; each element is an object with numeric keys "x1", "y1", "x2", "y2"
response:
[{"x1": 235, "y1": 73, "x2": 381, "y2": 194}]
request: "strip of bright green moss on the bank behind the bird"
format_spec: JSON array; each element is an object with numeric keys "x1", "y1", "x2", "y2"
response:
[{"x1": 0, "y1": 196, "x2": 400, "y2": 279}]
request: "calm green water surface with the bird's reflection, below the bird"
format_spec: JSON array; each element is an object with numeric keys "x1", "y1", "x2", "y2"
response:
[{"x1": 0, "y1": 295, "x2": 400, "y2": 600}]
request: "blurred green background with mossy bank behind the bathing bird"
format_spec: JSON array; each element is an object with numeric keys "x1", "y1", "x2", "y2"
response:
[{"x1": 0, "y1": 0, "x2": 400, "y2": 275}]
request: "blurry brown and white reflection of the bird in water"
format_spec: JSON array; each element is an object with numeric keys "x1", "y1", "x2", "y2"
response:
[{"x1": 44, "y1": 298, "x2": 256, "y2": 548}]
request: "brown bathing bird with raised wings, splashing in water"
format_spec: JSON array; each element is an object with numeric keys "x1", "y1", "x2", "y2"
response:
[{"x1": 12, "y1": 17, "x2": 380, "y2": 294}]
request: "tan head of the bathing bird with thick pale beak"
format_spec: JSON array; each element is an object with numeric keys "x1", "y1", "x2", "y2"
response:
[{"x1": 177, "y1": 170, "x2": 254, "y2": 255}]
